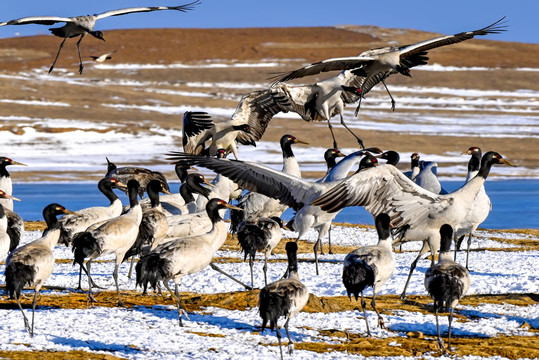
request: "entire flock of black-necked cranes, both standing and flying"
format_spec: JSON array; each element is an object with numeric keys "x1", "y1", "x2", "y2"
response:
[{"x1": 0, "y1": 0, "x2": 512, "y2": 358}]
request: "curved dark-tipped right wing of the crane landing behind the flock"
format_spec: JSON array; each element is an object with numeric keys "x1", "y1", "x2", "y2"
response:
[{"x1": 232, "y1": 89, "x2": 290, "y2": 145}]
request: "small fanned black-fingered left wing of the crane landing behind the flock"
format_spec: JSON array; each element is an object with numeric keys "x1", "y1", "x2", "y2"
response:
[{"x1": 182, "y1": 111, "x2": 214, "y2": 154}]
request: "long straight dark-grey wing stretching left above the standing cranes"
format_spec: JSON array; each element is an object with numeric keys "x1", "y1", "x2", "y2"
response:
[{"x1": 167, "y1": 152, "x2": 329, "y2": 210}]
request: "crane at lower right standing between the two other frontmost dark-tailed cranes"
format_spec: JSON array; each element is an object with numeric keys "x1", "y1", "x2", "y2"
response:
[{"x1": 342, "y1": 213, "x2": 395, "y2": 336}]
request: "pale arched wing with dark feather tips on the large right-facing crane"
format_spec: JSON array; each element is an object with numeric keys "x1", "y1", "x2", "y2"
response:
[{"x1": 312, "y1": 165, "x2": 453, "y2": 228}]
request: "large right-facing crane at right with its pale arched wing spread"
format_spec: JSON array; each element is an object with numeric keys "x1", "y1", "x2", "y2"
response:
[{"x1": 312, "y1": 151, "x2": 513, "y2": 298}]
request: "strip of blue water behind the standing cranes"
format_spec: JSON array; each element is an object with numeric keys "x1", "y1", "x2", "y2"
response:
[{"x1": 13, "y1": 180, "x2": 539, "y2": 229}]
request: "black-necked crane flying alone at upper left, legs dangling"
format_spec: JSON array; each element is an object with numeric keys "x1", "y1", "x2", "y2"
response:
[{"x1": 0, "y1": 0, "x2": 200, "y2": 74}]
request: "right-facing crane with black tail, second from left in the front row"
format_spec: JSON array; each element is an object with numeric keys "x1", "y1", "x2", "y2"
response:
[{"x1": 73, "y1": 180, "x2": 142, "y2": 306}]
